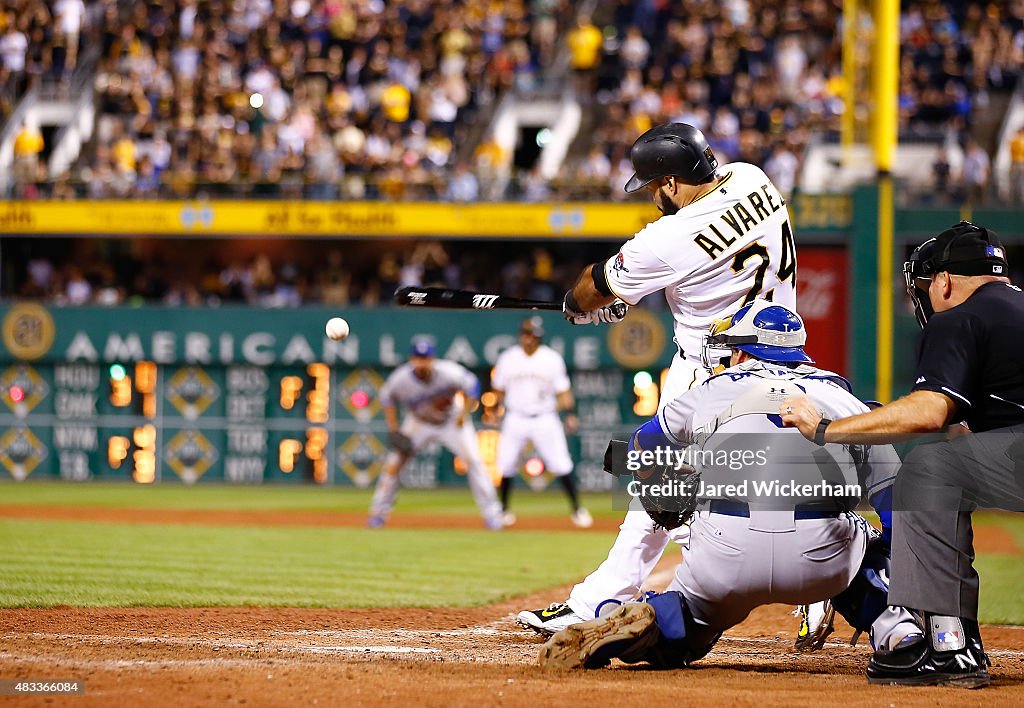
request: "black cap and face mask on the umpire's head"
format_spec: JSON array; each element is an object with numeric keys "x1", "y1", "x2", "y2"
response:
[{"x1": 903, "y1": 221, "x2": 1009, "y2": 327}]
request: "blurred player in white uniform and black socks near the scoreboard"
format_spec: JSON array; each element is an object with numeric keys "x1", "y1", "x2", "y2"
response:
[{"x1": 490, "y1": 317, "x2": 594, "y2": 529}]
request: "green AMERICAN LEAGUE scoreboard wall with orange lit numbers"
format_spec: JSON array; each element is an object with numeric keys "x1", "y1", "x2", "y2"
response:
[{"x1": 0, "y1": 303, "x2": 672, "y2": 489}]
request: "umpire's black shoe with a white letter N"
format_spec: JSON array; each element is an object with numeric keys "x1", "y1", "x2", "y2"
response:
[{"x1": 867, "y1": 615, "x2": 991, "y2": 689}]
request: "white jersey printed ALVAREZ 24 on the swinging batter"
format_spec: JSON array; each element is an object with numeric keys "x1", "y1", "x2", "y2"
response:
[{"x1": 604, "y1": 162, "x2": 797, "y2": 365}]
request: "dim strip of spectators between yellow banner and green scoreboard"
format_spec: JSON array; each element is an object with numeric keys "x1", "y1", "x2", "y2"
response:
[{"x1": 9, "y1": 241, "x2": 598, "y2": 307}]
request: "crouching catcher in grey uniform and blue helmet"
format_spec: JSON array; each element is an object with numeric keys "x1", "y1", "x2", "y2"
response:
[{"x1": 541, "y1": 300, "x2": 921, "y2": 668}]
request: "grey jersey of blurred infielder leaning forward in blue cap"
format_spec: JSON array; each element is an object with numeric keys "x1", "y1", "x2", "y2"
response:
[{"x1": 380, "y1": 360, "x2": 479, "y2": 425}]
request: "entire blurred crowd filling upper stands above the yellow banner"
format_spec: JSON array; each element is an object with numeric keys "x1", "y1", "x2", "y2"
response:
[{"x1": 0, "y1": 0, "x2": 1024, "y2": 201}]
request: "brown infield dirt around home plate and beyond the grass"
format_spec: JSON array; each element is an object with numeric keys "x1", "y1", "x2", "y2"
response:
[{"x1": 0, "y1": 507, "x2": 1024, "y2": 708}]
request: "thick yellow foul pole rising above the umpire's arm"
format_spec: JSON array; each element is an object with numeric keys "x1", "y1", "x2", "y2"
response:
[{"x1": 871, "y1": 0, "x2": 899, "y2": 403}]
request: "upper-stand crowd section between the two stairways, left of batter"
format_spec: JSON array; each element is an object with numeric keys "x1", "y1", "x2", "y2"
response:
[{"x1": 9, "y1": 0, "x2": 571, "y2": 199}]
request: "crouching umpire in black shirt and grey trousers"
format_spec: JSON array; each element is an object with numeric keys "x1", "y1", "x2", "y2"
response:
[{"x1": 780, "y1": 221, "x2": 1024, "y2": 688}]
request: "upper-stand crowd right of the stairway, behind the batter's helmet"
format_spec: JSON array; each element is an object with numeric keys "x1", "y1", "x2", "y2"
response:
[{"x1": 557, "y1": 0, "x2": 1024, "y2": 199}]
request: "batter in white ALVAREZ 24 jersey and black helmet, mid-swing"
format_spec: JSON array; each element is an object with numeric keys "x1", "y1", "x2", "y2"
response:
[{"x1": 516, "y1": 123, "x2": 811, "y2": 633}]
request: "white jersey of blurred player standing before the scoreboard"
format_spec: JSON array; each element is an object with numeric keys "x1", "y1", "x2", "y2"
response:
[{"x1": 490, "y1": 344, "x2": 569, "y2": 416}]
